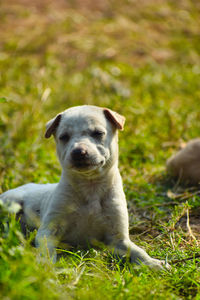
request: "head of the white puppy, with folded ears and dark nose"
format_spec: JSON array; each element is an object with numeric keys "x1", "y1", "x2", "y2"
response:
[{"x1": 45, "y1": 105, "x2": 125, "y2": 174}]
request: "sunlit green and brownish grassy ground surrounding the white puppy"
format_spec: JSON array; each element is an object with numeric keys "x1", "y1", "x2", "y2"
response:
[{"x1": 0, "y1": 0, "x2": 200, "y2": 300}]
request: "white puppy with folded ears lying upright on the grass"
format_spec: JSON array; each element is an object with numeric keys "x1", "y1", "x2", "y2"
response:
[{"x1": 0, "y1": 105, "x2": 164, "y2": 268}]
